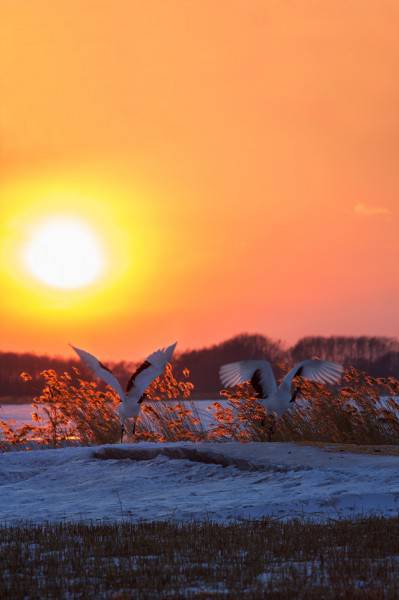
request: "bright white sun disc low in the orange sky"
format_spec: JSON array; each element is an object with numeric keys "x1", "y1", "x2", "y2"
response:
[{"x1": 24, "y1": 217, "x2": 104, "y2": 289}]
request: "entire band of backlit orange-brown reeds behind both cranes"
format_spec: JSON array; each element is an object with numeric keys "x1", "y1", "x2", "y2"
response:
[{"x1": 0, "y1": 365, "x2": 399, "y2": 447}]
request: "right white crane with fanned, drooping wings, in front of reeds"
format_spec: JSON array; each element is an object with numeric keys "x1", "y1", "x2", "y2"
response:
[{"x1": 219, "y1": 359, "x2": 343, "y2": 439}]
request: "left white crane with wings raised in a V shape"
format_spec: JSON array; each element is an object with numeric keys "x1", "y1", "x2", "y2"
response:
[{"x1": 71, "y1": 342, "x2": 177, "y2": 442}]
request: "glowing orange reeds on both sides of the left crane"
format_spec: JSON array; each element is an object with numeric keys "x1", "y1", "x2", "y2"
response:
[{"x1": 0, "y1": 365, "x2": 200, "y2": 448}]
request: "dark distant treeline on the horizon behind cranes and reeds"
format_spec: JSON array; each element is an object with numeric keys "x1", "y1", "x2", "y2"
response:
[{"x1": 0, "y1": 334, "x2": 399, "y2": 402}]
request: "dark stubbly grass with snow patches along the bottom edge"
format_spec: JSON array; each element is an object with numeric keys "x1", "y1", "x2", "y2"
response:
[{"x1": 0, "y1": 518, "x2": 399, "y2": 600}]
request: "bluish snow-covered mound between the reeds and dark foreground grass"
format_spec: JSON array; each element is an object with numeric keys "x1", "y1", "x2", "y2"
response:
[{"x1": 0, "y1": 442, "x2": 399, "y2": 523}]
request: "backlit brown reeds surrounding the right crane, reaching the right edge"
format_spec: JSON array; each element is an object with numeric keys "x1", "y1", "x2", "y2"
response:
[{"x1": 213, "y1": 368, "x2": 399, "y2": 444}]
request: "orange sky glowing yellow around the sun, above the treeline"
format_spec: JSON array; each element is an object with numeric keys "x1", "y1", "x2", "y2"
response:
[{"x1": 0, "y1": 0, "x2": 399, "y2": 360}]
